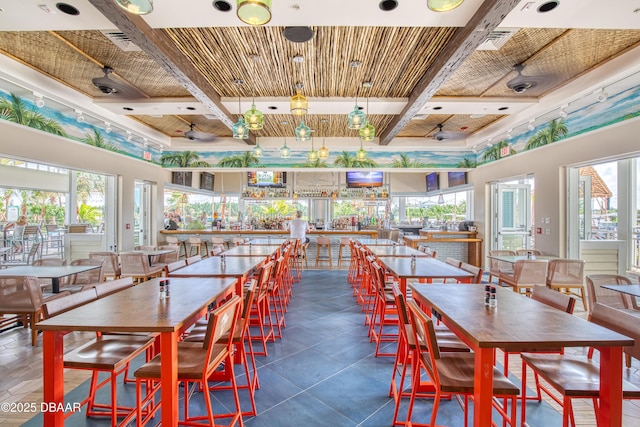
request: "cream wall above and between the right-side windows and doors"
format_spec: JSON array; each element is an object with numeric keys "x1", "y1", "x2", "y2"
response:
[{"x1": 469, "y1": 119, "x2": 640, "y2": 256}]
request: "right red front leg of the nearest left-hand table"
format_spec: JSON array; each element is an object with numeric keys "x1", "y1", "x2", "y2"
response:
[{"x1": 160, "y1": 332, "x2": 179, "y2": 427}]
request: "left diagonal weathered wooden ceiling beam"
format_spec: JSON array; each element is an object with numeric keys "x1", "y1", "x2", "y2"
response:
[{"x1": 89, "y1": 0, "x2": 256, "y2": 145}]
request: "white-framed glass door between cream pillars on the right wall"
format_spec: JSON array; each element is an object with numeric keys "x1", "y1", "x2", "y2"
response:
[{"x1": 491, "y1": 184, "x2": 533, "y2": 251}]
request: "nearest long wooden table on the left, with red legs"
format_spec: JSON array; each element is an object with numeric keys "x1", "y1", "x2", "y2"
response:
[{"x1": 35, "y1": 278, "x2": 237, "y2": 427}]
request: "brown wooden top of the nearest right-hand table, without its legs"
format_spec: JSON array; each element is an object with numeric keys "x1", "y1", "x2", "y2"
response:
[{"x1": 409, "y1": 284, "x2": 633, "y2": 350}]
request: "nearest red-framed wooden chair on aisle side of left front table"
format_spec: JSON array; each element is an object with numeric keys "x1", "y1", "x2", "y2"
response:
[{"x1": 134, "y1": 295, "x2": 242, "y2": 426}]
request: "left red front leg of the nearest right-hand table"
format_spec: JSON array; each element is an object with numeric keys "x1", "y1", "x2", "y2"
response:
[{"x1": 473, "y1": 348, "x2": 495, "y2": 426}]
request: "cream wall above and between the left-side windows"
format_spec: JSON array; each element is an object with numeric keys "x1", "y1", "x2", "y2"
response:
[{"x1": 0, "y1": 120, "x2": 170, "y2": 250}]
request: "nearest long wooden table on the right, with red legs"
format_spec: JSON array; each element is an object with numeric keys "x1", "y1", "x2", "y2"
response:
[{"x1": 410, "y1": 284, "x2": 633, "y2": 427}]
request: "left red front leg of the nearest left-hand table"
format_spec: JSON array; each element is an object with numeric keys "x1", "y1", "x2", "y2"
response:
[{"x1": 42, "y1": 331, "x2": 65, "y2": 426}]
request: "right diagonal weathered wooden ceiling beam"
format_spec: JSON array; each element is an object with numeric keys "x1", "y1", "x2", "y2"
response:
[{"x1": 380, "y1": 0, "x2": 520, "y2": 145}]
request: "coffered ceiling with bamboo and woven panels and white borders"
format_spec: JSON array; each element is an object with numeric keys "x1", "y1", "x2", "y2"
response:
[{"x1": 0, "y1": 0, "x2": 640, "y2": 150}]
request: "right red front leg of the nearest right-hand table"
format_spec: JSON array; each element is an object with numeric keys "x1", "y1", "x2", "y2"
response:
[{"x1": 597, "y1": 347, "x2": 622, "y2": 427}]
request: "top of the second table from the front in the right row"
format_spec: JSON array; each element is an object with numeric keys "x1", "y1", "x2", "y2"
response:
[{"x1": 380, "y1": 257, "x2": 473, "y2": 279}]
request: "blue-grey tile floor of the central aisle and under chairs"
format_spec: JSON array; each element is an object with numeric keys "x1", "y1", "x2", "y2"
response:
[{"x1": 25, "y1": 270, "x2": 572, "y2": 427}]
